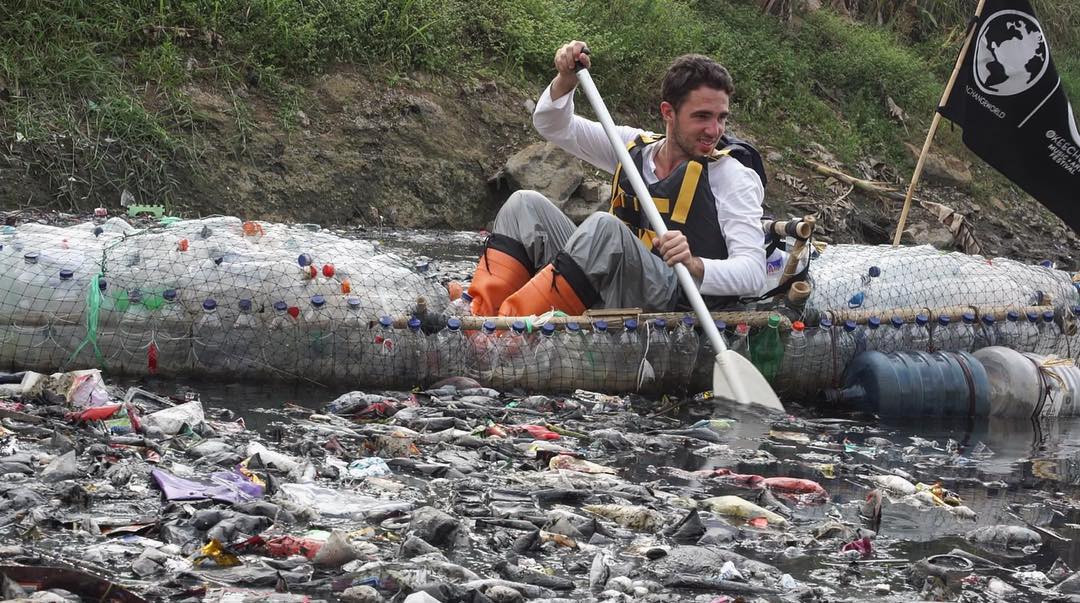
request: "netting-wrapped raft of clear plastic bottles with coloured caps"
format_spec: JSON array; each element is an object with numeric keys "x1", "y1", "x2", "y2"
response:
[{"x1": 0, "y1": 217, "x2": 1080, "y2": 399}]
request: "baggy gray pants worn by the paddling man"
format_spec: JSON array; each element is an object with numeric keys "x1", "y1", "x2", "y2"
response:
[{"x1": 494, "y1": 190, "x2": 679, "y2": 312}]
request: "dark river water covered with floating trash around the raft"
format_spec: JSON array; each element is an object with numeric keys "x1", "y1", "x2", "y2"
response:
[{"x1": 6, "y1": 231, "x2": 1080, "y2": 603}]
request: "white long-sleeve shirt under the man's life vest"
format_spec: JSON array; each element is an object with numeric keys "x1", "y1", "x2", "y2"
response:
[{"x1": 532, "y1": 82, "x2": 765, "y2": 296}]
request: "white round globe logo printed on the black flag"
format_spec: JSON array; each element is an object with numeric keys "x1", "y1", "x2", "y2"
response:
[{"x1": 974, "y1": 11, "x2": 1050, "y2": 96}]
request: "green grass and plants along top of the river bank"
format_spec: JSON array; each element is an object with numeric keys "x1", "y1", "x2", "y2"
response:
[{"x1": 0, "y1": 0, "x2": 1080, "y2": 206}]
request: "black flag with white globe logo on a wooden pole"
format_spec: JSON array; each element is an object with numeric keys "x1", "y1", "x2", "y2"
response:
[{"x1": 937, "y1": 0, "x2": 1080, "y2": 232}]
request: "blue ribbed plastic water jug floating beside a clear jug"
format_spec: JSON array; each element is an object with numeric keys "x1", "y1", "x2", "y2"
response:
[{"x1": 824, "y1": 351, "x2": 990, "y2": 417}]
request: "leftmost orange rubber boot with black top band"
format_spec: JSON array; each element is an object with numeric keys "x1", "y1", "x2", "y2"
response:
[{"x1": 469, "y1": 235, "x2": 532, "y2": 317}]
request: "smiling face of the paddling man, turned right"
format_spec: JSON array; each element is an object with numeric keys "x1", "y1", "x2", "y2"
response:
[{"x1": 660, "y1": 86, "x2": 730, "y2": 161}]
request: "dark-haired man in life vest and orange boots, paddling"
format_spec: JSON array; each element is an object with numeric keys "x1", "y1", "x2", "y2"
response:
[{"x1": 454, "y1": 41, "x2": 765, "y2": 316}]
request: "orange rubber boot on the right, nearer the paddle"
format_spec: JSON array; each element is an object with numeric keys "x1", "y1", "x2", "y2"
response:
[{"x1": 499, "y1": 254, "x2": 599, "y2": 317}]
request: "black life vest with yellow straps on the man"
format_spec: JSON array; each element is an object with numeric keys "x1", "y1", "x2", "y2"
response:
[{"x1": 610, "y1": 134, "x2": 766, "y2": 309}]
